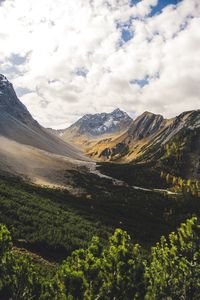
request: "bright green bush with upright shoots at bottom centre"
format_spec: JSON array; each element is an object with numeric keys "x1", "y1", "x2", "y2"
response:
[{"x1": 59, "y1": 229, "x2": 144, "y2": 300}]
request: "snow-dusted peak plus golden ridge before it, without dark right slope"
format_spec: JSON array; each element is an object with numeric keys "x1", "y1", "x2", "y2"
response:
[{"x1": 48, "y1": 108, "x2": 170, "y2": 161}]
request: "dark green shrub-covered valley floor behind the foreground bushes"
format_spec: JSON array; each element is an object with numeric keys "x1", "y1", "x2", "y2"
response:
[{"x1": 0, "y1": 164, "x2": 200, "y2": 261}]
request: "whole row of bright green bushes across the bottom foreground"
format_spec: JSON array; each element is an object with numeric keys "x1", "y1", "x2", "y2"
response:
[{"x1": 0, "y1": 218, "x2": 200, "y2": 300}]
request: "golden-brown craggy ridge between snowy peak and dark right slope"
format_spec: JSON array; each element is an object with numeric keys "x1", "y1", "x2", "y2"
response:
[{"x1": 88, "y1": 112, "x2": 171, "y2": 161}]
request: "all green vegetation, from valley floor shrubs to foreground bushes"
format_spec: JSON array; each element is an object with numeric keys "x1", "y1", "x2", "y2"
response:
[{"x1": 0, "y1": 164, "x2": 200, "y2": 300}]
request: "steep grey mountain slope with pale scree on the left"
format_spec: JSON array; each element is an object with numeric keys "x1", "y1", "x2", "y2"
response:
[{"x1": 0, "y1": 75, "x2": 93, "y2": 188}]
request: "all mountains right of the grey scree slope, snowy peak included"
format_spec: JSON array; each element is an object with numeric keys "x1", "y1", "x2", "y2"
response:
[{"x1": 48, "y1": 103, "x2": 200, "y2": 177}]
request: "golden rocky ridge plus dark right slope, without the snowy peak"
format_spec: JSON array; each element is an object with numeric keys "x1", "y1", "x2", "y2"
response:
[{"x1": 87, "y1": 110, "x2": 200, "y2": 178}]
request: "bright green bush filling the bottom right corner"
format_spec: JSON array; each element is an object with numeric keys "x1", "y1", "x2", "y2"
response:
[{"x1": 145, "y1": 218, "x2": 200, "y2": 300}]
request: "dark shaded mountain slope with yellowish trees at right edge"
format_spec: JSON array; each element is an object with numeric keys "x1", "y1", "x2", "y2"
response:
[{"x1": 136, "y1": 110, "x2": 200, "y2": 178}]
